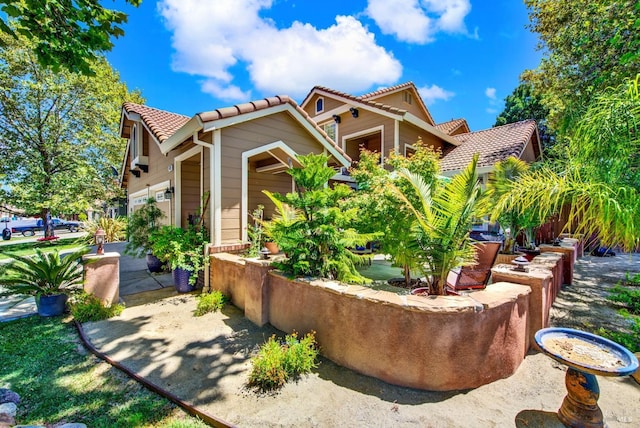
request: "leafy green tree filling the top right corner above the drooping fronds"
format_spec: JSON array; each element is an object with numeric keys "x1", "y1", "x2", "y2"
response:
[{"x1": 523, "y1": 0, "x2": 640, "y2": 128}]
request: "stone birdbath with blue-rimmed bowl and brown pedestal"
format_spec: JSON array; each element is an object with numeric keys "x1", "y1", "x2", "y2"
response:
[{"x1": 535, "y1": 327, "x2": 638, "y2": 428}]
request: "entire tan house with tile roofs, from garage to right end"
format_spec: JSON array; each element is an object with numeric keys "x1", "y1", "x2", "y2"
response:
[{"x1": 120, "y1": 82, "x2": 541, "y2": 247}]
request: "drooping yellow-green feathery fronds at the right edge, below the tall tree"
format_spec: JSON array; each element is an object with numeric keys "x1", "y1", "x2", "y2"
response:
[{"x1": 492, "y1": 75, "x2": 640, "y2": 250}]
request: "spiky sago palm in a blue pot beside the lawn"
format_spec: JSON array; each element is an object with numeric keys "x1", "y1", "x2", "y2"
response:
[{"x1": 0, "y1": 247, "x2": 90, "y2": 317}]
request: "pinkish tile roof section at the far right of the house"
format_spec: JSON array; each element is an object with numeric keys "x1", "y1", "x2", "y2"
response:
[{"x1": 441, "y1": 120, "x2": 537, "y2": 171}]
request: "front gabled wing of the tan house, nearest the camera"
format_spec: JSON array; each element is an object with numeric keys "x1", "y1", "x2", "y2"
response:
[{"x1": 120, "y1": 96, "x2": 351, "y2": 251}]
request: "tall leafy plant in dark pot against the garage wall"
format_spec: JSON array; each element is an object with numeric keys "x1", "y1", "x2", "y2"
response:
[{"x1": 124, "y1": 198, "x2": 164, "y2": 272}]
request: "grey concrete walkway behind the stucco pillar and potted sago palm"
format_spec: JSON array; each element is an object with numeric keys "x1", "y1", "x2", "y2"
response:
[{"x1": 0, "y1": 242, "x2": 178, "y2": 322}]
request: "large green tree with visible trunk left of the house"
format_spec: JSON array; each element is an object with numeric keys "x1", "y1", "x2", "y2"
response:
[{"x1": 0, "y1": 36, "x2": 142, "y2": 234}]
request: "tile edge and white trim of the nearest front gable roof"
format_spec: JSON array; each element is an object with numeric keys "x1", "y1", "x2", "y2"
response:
[{"x1": 197, "y1": 95, "x2": 351, "y2": 162}]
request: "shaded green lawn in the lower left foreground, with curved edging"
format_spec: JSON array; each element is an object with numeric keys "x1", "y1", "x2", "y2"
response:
[{"x1": 0, "y1": 316, "x2": 206, "y2": 428}]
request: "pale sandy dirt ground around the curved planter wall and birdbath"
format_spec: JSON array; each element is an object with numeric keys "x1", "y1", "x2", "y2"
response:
[{"x1": 84, "y1": 254, "x2": 640, "y2": 428}]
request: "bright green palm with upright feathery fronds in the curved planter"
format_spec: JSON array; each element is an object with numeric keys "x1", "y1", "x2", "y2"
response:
[{"x1": 393, "y1": 155, "x2": 482, "y2": 295}]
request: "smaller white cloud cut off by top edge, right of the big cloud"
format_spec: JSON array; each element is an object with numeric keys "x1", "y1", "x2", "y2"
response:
[{"x1": 366, "y1": 0, "x2": 471, "y2": 44}]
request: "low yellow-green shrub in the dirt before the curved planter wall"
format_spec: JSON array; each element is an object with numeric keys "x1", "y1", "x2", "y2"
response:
[{"x1": 249, "y1": 331, "x2": 318, "y2": 391}]
